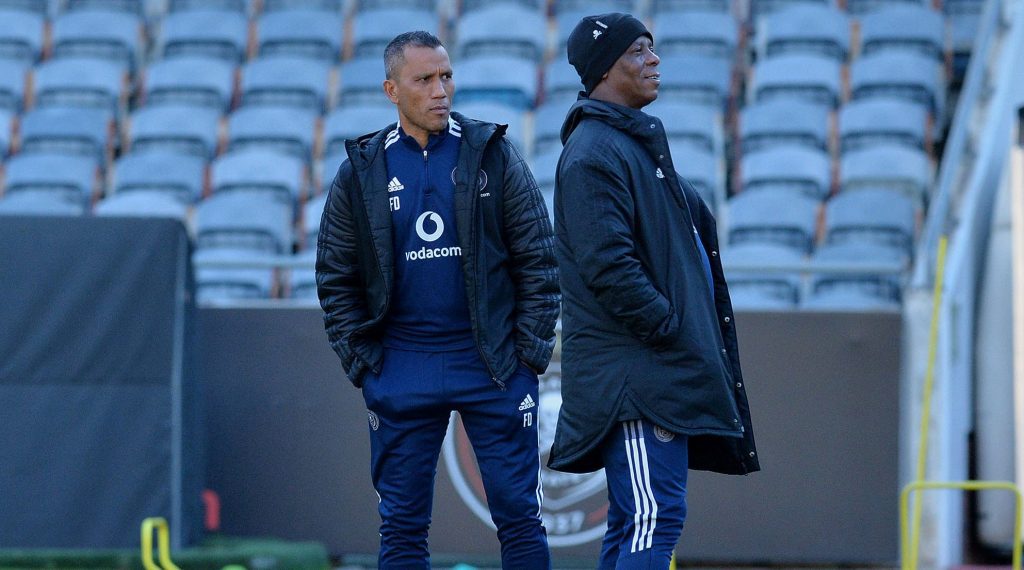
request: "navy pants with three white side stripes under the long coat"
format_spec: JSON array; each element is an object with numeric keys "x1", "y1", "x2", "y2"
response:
[{"x1": 598, "y1": 420, "x2": 689, "y2": 570}]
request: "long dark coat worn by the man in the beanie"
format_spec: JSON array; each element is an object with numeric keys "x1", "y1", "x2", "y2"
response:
[{"x1": 549, "y1": 99, "x2": 759, "y2": 474}]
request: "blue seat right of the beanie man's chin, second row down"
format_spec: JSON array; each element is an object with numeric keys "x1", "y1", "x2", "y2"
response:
[{"x1": 658, "y1": 54, "x2": 732, "y2": 108}]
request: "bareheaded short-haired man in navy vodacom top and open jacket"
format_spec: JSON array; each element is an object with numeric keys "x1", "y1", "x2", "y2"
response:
[{"x1": 316, "y1": 32, "x2": 559, "y2": 569}]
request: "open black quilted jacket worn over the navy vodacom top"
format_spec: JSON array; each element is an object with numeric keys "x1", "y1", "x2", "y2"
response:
[{"x1": 316, "y1": 113, "x2": 559, "y2": 387}]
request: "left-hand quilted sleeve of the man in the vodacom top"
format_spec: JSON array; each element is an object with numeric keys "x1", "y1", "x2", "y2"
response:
[{"x1": 316, "y1": 161, "x2": 369, "y2": 387}]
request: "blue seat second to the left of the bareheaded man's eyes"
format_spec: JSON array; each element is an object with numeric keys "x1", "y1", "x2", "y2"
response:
[{"x1": 241, "y1": 56, "x2": 330, "y2": 115}]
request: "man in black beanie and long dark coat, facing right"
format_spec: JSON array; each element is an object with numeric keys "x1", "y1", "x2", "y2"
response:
[{"x1": 548, "y1": 13, "x2": 760, "y2": 569}]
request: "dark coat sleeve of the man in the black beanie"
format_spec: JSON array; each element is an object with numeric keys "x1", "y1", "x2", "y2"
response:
[{"x1": 558, "y1": 153, "x2": 681, "y2": 347}]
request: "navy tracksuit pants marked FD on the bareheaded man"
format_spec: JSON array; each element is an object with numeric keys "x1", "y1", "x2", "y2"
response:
[{"x1": 362, "y1": 348, "x2": 551, "y2": 569}]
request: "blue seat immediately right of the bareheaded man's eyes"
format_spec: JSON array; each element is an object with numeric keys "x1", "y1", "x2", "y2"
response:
[{"x1": 456, "y1": 55, "x2": 539, "y2": 109}]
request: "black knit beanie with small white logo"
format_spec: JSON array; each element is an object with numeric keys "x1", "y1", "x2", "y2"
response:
[{"x1": 568, "y1": 12, "x2": 654, "y2": 93}]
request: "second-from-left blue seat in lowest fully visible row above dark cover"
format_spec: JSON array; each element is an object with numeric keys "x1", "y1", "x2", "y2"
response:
[{"x1": 111, "y1": 150, "x2": 206, "y2": 204}]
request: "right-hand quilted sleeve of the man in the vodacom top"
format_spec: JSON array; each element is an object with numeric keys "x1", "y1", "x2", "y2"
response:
[{"x1": 501, "y1": 139, "x2": 561, "y2": 372}]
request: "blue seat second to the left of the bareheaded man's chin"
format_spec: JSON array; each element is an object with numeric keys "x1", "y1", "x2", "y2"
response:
[{"x1": 227, "y1": 106, "x2": 316, "y2": 163}]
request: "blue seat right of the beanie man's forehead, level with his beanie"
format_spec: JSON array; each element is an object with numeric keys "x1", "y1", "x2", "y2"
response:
[{"x1": 653, "y1": 11, "x2": 739, "y2": 60}]
